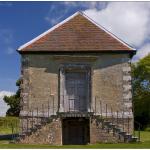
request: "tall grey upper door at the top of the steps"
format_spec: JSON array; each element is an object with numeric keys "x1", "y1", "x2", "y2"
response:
[{"x1": 65, "y1": 72, "x2": 88, "y2": 111}]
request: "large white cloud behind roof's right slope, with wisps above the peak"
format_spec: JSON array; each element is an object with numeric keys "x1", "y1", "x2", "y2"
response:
[{"x1": 45, "y1": 1, "x2": 150, "y2": 59}]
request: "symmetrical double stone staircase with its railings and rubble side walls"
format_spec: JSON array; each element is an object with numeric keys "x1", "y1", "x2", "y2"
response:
[{"x1": 14, "y1": 95, "x2": 140, "y2": 144}]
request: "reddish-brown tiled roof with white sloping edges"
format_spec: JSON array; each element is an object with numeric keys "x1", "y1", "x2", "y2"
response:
[{"x1": 18, "y1": 12, "x2": 134, "y2": 52}]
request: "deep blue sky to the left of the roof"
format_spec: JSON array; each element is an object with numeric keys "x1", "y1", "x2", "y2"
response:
[{"x1": 0, "y1": 2, "x2": 106, "y2": 92}]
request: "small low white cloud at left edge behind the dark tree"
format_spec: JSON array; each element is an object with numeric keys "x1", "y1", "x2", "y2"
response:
[{"x1": 0, "y1": 91, "x2": 14, "y2": 116}]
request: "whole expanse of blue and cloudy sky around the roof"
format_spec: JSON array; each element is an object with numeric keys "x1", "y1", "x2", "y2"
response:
[{"x1": 0, "y1": 1, "x2": 150, "y2": 92}]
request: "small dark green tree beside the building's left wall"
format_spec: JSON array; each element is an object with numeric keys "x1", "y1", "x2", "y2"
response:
[{"x1": 3, "y1": 79, "x2": 21, "y2": 117}]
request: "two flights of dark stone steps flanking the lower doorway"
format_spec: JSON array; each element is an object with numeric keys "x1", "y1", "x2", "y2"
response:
[{"x1": 15, "y1": 115, "x2": 139, "y2": 143}]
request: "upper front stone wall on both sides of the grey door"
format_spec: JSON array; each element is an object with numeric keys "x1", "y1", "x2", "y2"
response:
[{"x1": 21, "y1": 54, "x2": 133, "y2": 130}]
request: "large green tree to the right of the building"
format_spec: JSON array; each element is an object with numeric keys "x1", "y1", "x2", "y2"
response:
[{"x1": 132, "y1": 55, "x2": 150, "y2": 128}]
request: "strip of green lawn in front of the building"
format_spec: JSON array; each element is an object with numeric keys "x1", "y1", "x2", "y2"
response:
[{"x1": 0, "y1": 131, "x2": 150, "y2": 149}]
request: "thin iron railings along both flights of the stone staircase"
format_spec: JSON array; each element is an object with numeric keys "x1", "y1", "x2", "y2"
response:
[{"x1": 17, "y1": 95, "x2": 140, "y2": 141}]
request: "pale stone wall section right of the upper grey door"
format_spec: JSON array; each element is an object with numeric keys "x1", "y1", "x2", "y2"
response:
[{"x1": 92, "y1": 55, "x2": 132, "y2": 114}]
